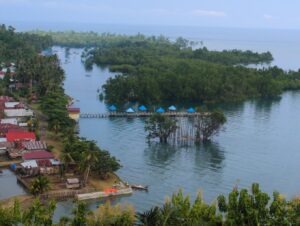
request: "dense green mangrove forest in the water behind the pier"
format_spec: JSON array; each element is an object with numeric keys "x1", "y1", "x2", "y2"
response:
[{"x1": 66, "y1": 34, "x2": 300, "y2": 104}]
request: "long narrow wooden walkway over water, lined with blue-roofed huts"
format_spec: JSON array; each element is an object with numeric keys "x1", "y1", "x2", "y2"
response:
[{"x1": 80, "y1": 112, "x2": 202, "y2": 118}]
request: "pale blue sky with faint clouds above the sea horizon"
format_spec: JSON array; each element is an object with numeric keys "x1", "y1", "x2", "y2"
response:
[{"x1": 0, "y1": 0, "x2": 300, "y2": 29}]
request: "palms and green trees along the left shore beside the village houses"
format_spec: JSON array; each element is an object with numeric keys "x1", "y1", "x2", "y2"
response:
[{"x1": 0, "y1": 25, "x2": 121, "y2": 180}]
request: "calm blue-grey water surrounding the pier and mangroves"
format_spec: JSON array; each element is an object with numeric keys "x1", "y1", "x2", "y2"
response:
[{"x1": 54, "y1": 25, "x2": 300, "y2": 216}]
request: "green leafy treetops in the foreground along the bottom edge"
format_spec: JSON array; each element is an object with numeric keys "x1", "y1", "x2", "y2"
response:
[{"x1": 0, "y1": 184, "x2": 300, "y2": 226}]
